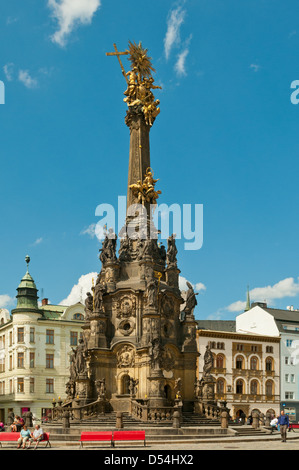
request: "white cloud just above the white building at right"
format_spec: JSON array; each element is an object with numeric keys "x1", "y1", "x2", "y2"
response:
[{"x1": 226, "y1": 277, "x2": 299, "y2": 312}]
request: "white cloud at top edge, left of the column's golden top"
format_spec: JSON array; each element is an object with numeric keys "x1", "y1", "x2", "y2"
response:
[{"x1": 48, "y1": 0, "x2": 101, "y2": 46}]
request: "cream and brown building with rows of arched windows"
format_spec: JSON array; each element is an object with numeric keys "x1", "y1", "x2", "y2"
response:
[{"x1": 197, "y1": 320, "x2": 280, "y2": 419}]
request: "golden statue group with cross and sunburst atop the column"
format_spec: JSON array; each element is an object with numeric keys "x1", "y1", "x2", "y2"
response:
[{"x1": 106, "y1": 41, "x2": 162, "y2": 126}]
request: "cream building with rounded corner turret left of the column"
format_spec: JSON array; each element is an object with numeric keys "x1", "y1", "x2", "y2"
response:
[{"x1": 0, "y1": 260, "x2": 85, "y2": 422}]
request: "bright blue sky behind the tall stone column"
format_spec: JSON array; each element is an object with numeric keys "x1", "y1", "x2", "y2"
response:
[{"x1": 0, "y1": 0, "x2": 299, "y2": 319}]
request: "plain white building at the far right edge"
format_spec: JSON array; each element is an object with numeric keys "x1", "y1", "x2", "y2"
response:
[{"x1": 236, "y1": 302, "x2": 299, "y2": 422}]
